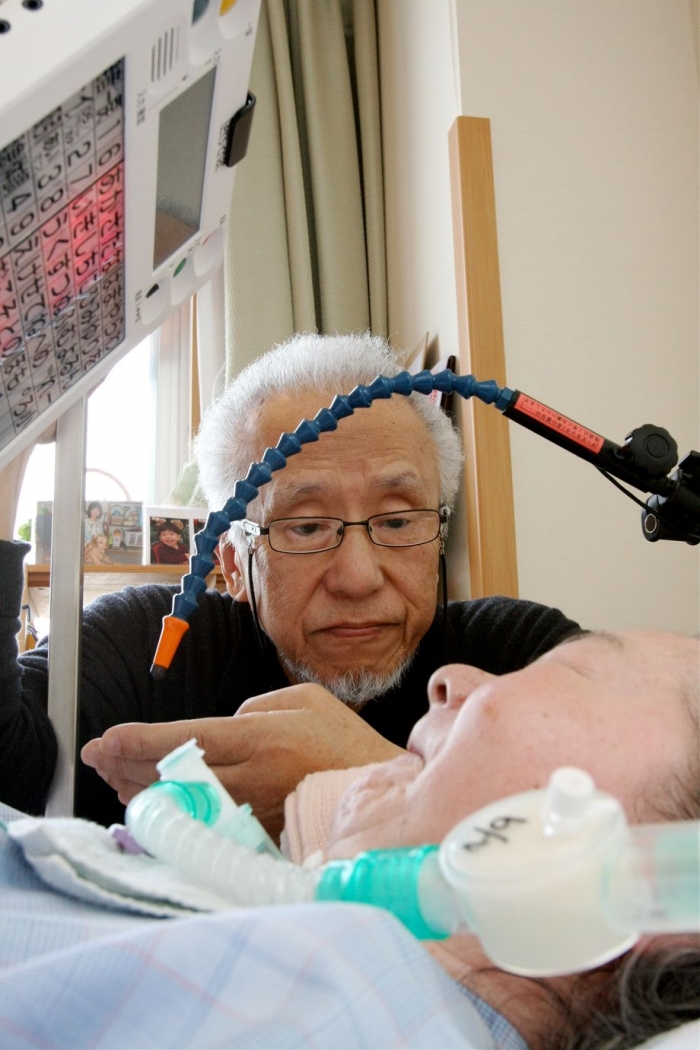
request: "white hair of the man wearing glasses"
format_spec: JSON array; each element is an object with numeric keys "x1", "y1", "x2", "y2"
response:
[{"x1": 195, "y1": 333, "x2": 463, "y2": 510}]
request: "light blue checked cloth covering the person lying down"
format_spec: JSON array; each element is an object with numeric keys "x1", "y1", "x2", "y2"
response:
[{"x1": 0, "y1": 793, "x2": 700, "y2": 1050}]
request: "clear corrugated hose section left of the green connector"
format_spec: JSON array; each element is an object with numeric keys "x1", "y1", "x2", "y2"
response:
[{"x1": 126, "y1": 789, "x2": 318, "y2": 906}]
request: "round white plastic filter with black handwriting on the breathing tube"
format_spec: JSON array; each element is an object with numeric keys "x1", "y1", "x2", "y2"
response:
[{"x1": 440, "y1": 768, "x2": 639, "y2": 977}]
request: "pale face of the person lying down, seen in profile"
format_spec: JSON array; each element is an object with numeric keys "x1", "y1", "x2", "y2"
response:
[{"x1": 330, "y1": 631, "x2": 699, "y2": 858}]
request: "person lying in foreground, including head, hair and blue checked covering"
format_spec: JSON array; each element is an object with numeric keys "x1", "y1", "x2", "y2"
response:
[{"x1": 0, "y1": 632, "x2": 700, "y2": 1050}]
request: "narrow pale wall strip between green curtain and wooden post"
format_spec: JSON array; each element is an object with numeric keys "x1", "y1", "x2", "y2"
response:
[{"x1": 378, "y1": 0, "x2": 468, "y2": 597}]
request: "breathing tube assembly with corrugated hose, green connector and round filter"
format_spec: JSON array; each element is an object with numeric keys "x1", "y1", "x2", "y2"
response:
[{"x1": 127, "y1": 768, "x2": 700, "y2": 977}]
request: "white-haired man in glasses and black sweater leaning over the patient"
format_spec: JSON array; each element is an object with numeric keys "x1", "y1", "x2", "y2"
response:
[{"x1": 0, "y1": 335, "x2": 577, "y2": 833}]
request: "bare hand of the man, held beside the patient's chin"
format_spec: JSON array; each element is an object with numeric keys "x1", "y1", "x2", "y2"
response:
[{"x1": 81, "y1": 685, "x2": 402, "y2": 839}]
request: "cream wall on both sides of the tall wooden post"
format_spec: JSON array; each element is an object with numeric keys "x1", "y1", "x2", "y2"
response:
[{"x1": 379, "y1": 0, "x2": 700, "y2": 631}]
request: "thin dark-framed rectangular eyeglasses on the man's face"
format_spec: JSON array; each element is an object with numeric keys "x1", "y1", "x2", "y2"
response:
[{"x1": 240, "y1": 507, "x2": 448, "y2": 554}]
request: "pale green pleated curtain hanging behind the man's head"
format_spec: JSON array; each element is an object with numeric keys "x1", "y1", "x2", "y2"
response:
[{"x1": 225, "y1": 0, "x2": 387, "y2": 381}]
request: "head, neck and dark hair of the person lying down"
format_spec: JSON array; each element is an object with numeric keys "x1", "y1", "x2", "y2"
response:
[{"x1": 285, "y1": 631, "x2": 700, "y2": 1048}]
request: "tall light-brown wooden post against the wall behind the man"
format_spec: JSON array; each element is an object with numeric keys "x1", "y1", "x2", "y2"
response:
[{"x1": 449, "y1": 117, "x2": 517, "y2": 597}]
